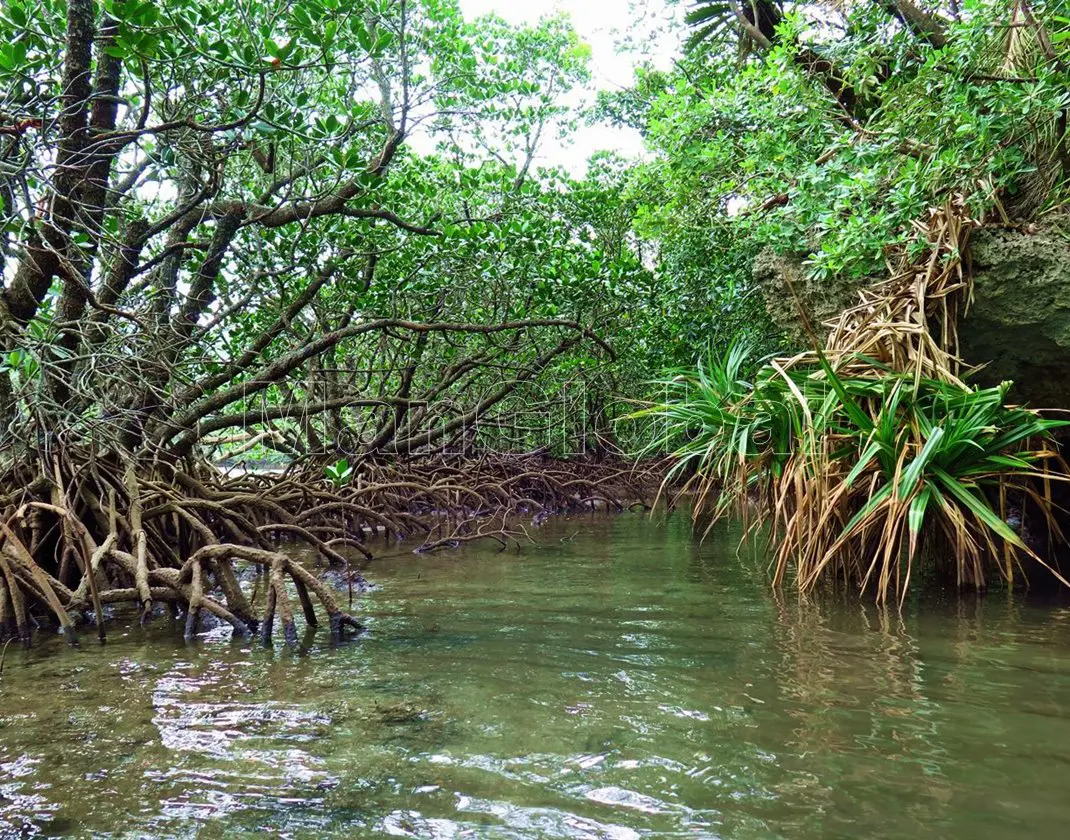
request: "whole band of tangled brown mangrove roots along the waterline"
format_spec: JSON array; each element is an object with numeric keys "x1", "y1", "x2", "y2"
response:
[{"x1": 0, "y1": 448, "x2": 649, "y2": 644}]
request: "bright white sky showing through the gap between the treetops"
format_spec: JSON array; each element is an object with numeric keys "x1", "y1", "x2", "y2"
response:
[{"x1": 460, "y1": 0, "x2": 676, "y2": 175}]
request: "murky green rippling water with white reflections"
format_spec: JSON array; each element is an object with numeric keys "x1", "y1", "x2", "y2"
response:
[{"x1": 0, "y1": 516, "x2": 1070, "y2": 840}]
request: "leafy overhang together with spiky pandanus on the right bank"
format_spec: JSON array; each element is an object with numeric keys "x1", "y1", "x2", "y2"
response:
[{"x1": 616, "y1": 0, "x2": 1070, "y2": 600}]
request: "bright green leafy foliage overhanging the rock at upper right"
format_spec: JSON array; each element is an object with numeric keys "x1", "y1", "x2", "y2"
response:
[{"x1": 600, "y1": 0, "x2": 1070, "y2": 361}]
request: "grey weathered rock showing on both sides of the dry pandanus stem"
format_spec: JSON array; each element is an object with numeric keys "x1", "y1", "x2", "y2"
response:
[{"x1": 753, "y1": 226, "x2": 1070, "y2": 409}]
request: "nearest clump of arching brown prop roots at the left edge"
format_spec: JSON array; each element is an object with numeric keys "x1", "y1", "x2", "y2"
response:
[{"x1": 0, "y1": 459, "x2": 367, "y2": 644}]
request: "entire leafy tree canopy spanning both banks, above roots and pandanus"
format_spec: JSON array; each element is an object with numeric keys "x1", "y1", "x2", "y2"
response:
[{"x1": 10, "y1": 0, "x2": 1068, "y2": 468}]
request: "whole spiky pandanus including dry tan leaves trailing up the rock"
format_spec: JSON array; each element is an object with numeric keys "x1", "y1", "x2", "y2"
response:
[{"x1": 637, "y1": 204, "x2": 1070, "y2": 601}]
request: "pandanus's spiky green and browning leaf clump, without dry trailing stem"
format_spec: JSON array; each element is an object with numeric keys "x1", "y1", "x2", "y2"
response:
[{"x1": 640, "y1": 346, "x2": 1070, "y2": 600}]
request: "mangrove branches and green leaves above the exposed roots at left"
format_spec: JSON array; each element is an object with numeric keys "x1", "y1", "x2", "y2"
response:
[{"x1": 0, "y1": 0, "x2": 659, "y2": 464}]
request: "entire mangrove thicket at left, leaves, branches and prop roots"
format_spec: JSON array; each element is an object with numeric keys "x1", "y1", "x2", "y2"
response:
[{"x1": 0, "y1": 0, "x2": 659, "y2": 640}]
